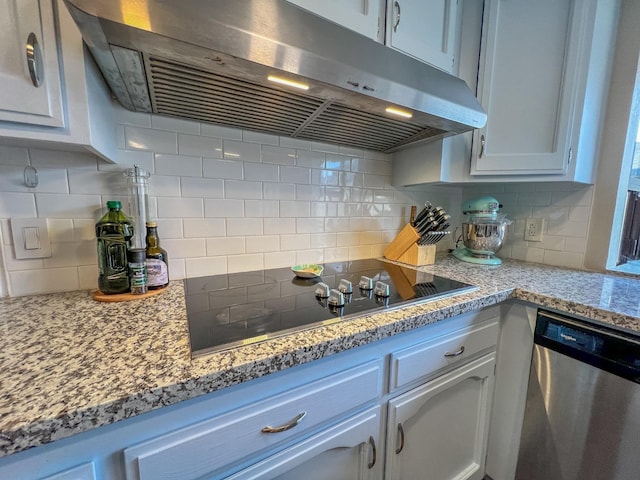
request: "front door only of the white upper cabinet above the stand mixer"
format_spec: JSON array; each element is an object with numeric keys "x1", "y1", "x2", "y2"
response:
[{"x1": 471, "y1": 0, "x2": 592, "y2": 175}]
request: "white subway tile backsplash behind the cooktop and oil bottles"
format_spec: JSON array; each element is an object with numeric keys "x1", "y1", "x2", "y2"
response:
[{"x1": 0, "y1": 108, "x2": 462, "y2": 296}]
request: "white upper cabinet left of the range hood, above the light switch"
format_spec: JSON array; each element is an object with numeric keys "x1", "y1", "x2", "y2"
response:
[{"x1": 0, "y1": 0, "x2": 116, "y2": 160}]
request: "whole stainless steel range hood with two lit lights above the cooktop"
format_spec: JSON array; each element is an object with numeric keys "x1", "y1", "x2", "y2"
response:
[{"x1": 65, "y1": 0, "x2": 486, "y2": 152}]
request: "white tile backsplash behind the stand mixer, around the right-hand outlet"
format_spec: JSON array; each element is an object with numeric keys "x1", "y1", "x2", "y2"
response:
[{"x1": 463, "y1": 183, "x2": 594, "y2": 269}]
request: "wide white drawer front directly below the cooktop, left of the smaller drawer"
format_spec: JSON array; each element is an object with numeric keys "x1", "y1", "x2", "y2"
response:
[{"x1": 124, "y1": 362, "x2": 381, "y2": 480}]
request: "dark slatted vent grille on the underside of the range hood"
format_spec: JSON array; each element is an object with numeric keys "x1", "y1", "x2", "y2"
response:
[{"x1": 145, "y1": 55, "x2": 445, "y2": 151}]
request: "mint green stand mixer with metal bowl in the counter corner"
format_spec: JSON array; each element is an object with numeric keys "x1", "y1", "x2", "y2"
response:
[{"x1": 453, "y1": 196, "x2": 511, "y2": 265}]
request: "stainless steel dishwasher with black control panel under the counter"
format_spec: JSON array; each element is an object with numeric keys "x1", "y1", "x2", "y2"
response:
[{"x1": 515, "y1": 310, "x2": 640, "y2": 480}]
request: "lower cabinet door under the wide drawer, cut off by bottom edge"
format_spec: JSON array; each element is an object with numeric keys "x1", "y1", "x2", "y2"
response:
[{"x1": 227, "y1": 407, "x2": 383, "y2": 480}]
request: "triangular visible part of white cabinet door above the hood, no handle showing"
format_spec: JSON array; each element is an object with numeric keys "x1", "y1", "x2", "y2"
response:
[{"x1": 288, "y1": 0, "x2": 384, "y2": 41}]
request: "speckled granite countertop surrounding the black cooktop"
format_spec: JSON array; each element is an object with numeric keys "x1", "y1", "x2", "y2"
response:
[{"x1": 0, "y1": 256, "x2": 640, "y2": 456}]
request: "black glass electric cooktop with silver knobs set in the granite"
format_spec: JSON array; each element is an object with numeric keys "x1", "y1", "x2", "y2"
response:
[{"x1": 184, "y1": 259, "x2": 476, "y2": 357}]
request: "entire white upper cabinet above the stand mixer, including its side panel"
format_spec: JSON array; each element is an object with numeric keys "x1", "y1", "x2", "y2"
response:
[{"x1": 471, "y1": 0, "x2": 617, "y2": 183}]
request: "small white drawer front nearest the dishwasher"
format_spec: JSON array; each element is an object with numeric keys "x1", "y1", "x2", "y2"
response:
[{"x1": 389, "y1": 318, "x2": 500, "y2": 391}]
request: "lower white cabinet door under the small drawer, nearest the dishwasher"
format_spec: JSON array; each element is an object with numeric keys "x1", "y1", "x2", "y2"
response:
[{"x1": 387, "y1": 353, "x2": 495, "y2": 480}]
